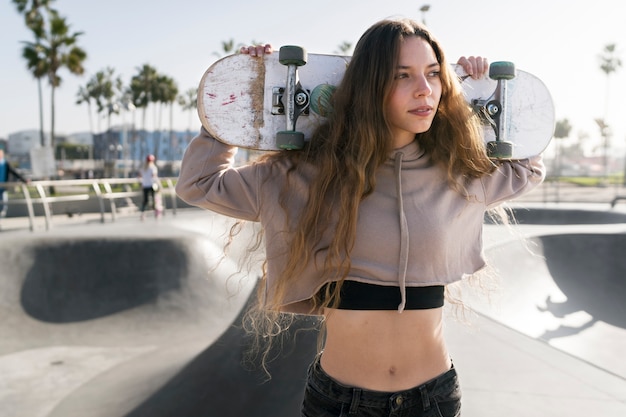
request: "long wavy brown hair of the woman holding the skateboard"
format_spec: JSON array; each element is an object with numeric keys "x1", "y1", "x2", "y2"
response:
[{"x1": 240, "y1": 19, "x2": 495, "y2": 370}]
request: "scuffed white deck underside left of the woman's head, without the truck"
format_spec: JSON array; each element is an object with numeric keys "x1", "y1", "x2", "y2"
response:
[{"x1": 198, "y1": 54, "x2": 349, "y2": 150}]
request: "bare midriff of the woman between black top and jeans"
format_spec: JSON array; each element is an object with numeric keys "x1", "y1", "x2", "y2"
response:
[{"x1": 321, "y1": 308, "x2": 451, "y2": 392}]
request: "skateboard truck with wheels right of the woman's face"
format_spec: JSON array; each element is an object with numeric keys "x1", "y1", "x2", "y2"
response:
[{"x1": 484, "y1": 61, "x2": 515, "y2": 158}]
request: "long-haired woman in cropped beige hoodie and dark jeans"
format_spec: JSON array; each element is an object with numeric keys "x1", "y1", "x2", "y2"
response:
[{"x1": 176, "y1": 20, "x2": 544, "y2": 417}]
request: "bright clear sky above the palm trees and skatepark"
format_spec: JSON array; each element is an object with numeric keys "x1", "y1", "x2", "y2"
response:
[{"x1": 0, "y1": 0, "x2": 626, "y2": 156}]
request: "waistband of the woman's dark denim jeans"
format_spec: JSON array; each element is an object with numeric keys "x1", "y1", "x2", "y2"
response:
[{"x1": 308, "y1": 355, "x2": 457, "y2": 408}]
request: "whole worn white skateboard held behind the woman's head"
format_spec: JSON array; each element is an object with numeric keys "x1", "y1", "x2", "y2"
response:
[{"x1": 198, "y1": 46, "x2": 555, "y2": 159}]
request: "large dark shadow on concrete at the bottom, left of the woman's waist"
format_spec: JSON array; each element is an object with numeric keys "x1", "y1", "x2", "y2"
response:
[{"x1": 125, "y1": 290, "x2": 318, "y2": 417}]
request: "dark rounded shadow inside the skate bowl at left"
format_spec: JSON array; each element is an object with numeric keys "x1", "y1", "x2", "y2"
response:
[{"x1": 21, "y1": 238, "x2": 190, "y2": 323}]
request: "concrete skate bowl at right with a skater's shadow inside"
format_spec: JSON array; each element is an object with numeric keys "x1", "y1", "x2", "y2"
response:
[{"x1": 475, "y1": 232, "x2": 626, "y2": 378}]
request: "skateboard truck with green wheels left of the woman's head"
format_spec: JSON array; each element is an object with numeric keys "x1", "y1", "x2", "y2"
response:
[{"x1": 272, "y1": 46, "x2": 310, "y2": 150}]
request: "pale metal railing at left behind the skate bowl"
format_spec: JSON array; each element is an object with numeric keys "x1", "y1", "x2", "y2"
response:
[{"x1": 0, "y1": 178, "x2": 177, "y2": 231}]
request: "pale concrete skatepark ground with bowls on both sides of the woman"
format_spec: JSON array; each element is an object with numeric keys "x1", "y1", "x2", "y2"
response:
[{"x1": 0, "y1": 202, "x2": 626, "y2": 417}]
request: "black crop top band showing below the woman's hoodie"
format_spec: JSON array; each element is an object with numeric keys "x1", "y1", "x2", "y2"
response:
[{"x1": 318, "y1": 280, "x2": 444, "y2": 310}]
